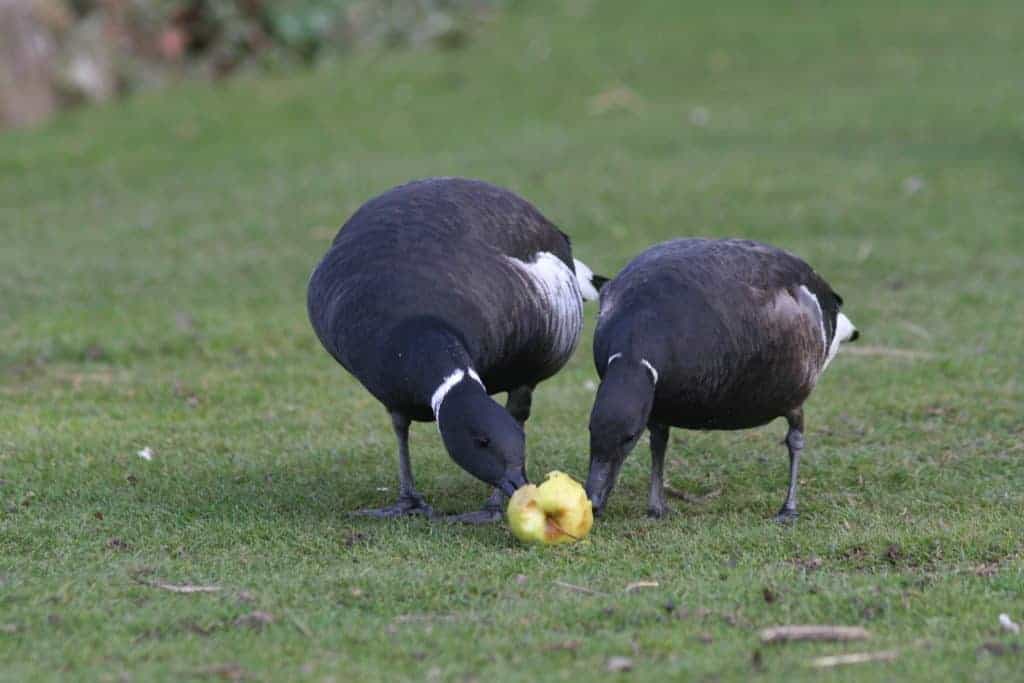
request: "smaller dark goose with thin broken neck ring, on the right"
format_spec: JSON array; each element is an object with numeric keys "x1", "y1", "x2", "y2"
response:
[{"x1": 586, "y1": 239, "x2": 860, "y2": 521}]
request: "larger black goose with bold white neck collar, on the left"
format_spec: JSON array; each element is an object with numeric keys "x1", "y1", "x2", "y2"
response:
[{"x1": 307, "y1": 178, "x2": 604, "y2": 523}]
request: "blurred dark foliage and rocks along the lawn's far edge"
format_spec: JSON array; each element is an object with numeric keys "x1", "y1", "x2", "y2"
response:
[{"x1": 0, "y1": 0, "x2": 502, "y2": 126}]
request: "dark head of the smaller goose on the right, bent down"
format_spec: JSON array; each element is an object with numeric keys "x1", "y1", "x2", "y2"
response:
[{"x1": 586, "y1": 357, "x2": 657, "y2": 514}]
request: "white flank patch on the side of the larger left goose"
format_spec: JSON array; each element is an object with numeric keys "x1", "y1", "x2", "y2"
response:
[{"x1": 509, "y1": 252, "x2": 583, "y2": 357}]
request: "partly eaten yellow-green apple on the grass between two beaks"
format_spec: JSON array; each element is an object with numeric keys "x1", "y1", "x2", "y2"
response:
[{"x1": 506, "y1": 470, "x2": 594, "y2": 546}]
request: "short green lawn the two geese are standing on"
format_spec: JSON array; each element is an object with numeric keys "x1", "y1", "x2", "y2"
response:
[{"x1": 0, "y1": 0, "x2": 1024, "y2": 682}]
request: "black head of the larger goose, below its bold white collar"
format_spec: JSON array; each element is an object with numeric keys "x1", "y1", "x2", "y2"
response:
[{"x1": 437, "y1": 375, "x2": 528, "y2": 496}]
